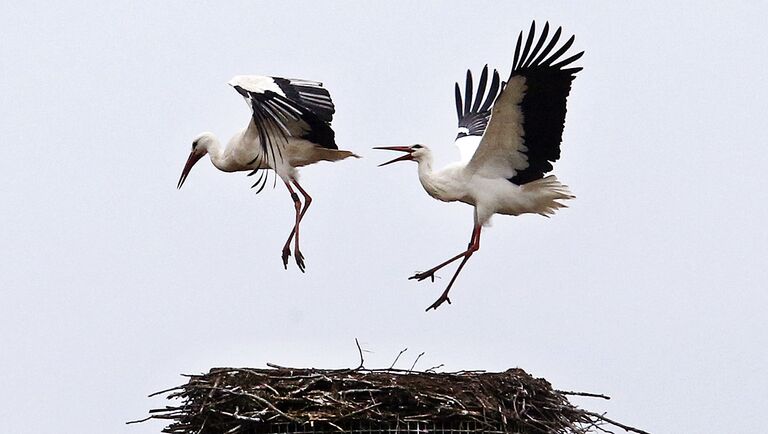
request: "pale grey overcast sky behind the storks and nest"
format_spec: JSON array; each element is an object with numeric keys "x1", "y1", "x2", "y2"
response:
[{"x1": 0, "y1": 1, "x2": 768, "y2": 434}]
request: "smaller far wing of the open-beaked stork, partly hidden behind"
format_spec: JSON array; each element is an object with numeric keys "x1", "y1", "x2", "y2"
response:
[{"x1": 454, "y1": 65, "x2": 501, "y2": 163}]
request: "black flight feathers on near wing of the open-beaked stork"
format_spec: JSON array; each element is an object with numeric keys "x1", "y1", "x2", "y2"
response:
[{"x1": 507, "y1": 23, "x2": 584, "y2": 185}]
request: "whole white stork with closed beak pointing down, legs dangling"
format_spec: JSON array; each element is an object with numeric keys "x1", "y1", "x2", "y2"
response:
[{"x1": 177, "y1": 75, "x2": 358, "y2": 272}]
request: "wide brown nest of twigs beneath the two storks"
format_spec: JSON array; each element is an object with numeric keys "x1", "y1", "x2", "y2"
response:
[{"x1": 136, "y1": 365, "x2": 647, "y2": 434}]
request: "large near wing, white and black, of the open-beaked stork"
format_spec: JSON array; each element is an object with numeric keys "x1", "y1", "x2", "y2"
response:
[{"x1": 467, "y1": 22, "x2": 584, "y2": 185}]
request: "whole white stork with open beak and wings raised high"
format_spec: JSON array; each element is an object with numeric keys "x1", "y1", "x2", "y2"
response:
[{"x1": 375, "y1": 22, "x2": 584, "y2": 310}]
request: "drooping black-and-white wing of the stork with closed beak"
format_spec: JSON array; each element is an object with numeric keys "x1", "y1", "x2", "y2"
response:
[{"x1": 229, "y1": 75, "x2": 338, "y2": 167}]
